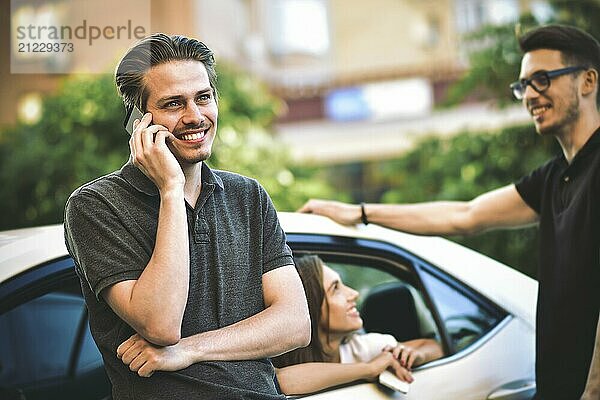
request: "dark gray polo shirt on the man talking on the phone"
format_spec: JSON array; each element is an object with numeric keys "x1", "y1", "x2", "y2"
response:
[{"x1": 65, "y1": 162, "x2": 293, "y2": 399}]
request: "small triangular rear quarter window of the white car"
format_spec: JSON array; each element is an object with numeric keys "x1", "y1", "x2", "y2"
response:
[{"x1": 421, "y1": 269, "x2": 503, "y2": 352}]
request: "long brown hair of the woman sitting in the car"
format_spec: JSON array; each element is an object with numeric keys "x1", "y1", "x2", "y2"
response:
[{"x1": 271, "y1": 255, "x2": 331, "y2": 368}]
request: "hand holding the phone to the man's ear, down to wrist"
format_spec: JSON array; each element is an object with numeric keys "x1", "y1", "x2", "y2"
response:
[{"x1": 129, "y1": 113, "x2": 185, "y2": 194}]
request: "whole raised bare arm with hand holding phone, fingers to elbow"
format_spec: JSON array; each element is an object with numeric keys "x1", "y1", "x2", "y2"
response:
[{"x1": 102, "y1": 113, "x2": 190, "y2": 346}]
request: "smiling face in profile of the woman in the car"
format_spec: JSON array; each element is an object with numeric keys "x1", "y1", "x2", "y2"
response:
[{"x1": 320, "y1": 265, "x2": 363, "y2": 335}]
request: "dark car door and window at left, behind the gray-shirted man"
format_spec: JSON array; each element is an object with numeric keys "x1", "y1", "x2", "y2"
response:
[{"x1": 0, "y1": 258, "x2": 110, "y2": 400}]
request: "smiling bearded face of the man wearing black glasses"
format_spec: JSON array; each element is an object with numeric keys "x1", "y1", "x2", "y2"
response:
[{"x1": 519, "y1": 49, "x2": 580, "y2": 135}]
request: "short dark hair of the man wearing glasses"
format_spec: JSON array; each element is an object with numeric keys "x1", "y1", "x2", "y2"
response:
[{"x1": 519, "y1": 24, "x2": 600, "y2": 104}]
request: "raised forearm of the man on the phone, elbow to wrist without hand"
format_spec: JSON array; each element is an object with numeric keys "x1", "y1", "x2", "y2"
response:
[{"x1": 106, "y1": 190, "x2": 189, "y2": 345}]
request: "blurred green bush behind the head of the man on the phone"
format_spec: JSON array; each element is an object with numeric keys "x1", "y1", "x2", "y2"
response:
[{"x1": 0, "y1": 65, "x2": 331, "y2": 229}]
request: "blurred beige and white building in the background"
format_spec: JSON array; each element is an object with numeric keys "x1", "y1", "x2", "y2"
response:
[{"x1": 0, "y1": 0, "x2": 547, "y2": 163}]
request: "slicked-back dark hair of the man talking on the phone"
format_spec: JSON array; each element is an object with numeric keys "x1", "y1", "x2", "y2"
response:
[{"x1": 115, "y1": 33, "x2": 217, "y2": 111}]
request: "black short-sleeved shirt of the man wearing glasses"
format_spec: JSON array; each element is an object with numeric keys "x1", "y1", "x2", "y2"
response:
[{"x1": 516, "y1": 129, "x2": 600, "y2": 400}]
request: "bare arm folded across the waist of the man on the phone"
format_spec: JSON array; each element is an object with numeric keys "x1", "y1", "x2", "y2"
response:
[{"x1": 117, "y1": 265, "x2": 311, "y2": 376}]
